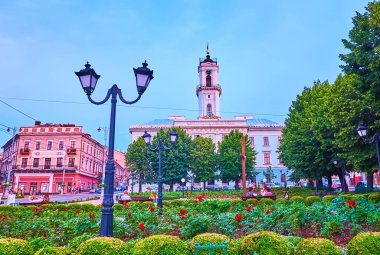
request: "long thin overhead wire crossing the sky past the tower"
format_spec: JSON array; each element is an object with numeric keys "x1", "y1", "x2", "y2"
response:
[{"x1": 0, "y1": 97, "x2": 287, "y2": 117}]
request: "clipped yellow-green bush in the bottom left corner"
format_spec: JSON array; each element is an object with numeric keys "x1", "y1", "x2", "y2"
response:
[{"x1": 0, "y1": 238, "x2": 34, "y2": 255}]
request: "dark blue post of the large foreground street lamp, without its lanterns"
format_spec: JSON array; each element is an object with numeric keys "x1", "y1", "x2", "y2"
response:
[{"x1": 100, "y1": 90, "x2": 117, "y2": 236}]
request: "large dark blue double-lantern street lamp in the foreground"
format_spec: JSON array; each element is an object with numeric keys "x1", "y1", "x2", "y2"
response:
[{"x1": 75, "y1": 61, "x2": 153, "y2": 237}]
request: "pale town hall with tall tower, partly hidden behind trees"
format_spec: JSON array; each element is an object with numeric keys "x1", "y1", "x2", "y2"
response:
[{"x1": 129, "y1": 47, "x2": 290, "y2": 184}]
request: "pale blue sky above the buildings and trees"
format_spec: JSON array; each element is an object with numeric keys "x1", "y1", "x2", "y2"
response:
[{"x1": 0, "y1": 0, "x2": 368, "y2": 151}]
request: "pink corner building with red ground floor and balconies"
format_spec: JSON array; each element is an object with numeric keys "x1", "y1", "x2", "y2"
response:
[{"x1": 1, "y1": 121, "x2": 104, "y2": 194}]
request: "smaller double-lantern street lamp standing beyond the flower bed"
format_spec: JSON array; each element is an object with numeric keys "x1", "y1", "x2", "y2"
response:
[{"x1": 142, "y1": 130, "x2": 178, "y2": 216}]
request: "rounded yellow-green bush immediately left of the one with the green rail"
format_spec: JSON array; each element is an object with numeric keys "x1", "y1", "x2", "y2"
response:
[{"x1": 133, "y1": 235, "x2": 191, "y2": 255}]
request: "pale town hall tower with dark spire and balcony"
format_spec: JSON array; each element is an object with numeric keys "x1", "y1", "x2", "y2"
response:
[{"x1": 196, "y1": 45, "x2": 222, "y2": 119}]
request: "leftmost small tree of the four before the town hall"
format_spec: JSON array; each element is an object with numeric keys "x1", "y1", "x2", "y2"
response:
[{"x1": 126, "y1": 137, "x2": 154, "y2": 192}]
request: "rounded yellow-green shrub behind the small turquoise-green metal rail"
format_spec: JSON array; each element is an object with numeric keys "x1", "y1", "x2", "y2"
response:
[{"x1": 189, "y1": 233, "x2": 239, "y2": 255}]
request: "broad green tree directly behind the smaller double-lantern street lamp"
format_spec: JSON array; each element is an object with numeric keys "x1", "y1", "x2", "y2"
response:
[{"x1": 148, "y1": 128, "x2": 192, "y2": 190}]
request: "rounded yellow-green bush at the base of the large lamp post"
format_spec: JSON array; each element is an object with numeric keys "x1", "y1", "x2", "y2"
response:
[{"x1": 77, "y1": 237, "x2": 123, "y2": 255}]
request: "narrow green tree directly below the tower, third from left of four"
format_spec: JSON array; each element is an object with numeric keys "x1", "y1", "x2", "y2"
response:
[{"x1": 190, "y1": 136, "x2": 218, "y2": 188}]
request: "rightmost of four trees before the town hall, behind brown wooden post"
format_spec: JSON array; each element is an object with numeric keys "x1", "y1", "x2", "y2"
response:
[{"x1": 219, "y1": 130, "x2": 256, "y2": 187}]
